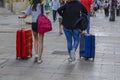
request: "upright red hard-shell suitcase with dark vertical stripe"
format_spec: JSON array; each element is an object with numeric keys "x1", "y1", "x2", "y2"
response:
[{"x1": 16, "y1": 28, "x2": 32, "y2": 59}]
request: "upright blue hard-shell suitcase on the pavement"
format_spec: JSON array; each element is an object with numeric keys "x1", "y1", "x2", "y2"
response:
[{"x1": 79, "y1": 34, "x2": 95, "y2": 60}]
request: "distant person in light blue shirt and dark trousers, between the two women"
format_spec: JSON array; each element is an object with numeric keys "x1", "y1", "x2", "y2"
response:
[{"x1": 51, "y1": 0, "x2": 60, "y2": 22}]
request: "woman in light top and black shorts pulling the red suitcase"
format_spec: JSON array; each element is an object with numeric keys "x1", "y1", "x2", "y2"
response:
[{"x1": 19, "y1": 0, "x2": 44, "y2": 64}]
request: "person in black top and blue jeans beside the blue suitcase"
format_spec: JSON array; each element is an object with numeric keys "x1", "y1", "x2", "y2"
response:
[{"x1": 58, "y1": 0, "x2": 87, "y2": 62}]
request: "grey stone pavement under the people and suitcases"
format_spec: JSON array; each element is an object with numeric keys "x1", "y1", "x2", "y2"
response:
[{"x1": 0, "y1": 9, "x2": 120, "y2": 80}]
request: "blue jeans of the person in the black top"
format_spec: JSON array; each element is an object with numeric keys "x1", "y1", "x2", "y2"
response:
[{"x1": 63, "y1": 27, "x2": 80, "y2": 53}]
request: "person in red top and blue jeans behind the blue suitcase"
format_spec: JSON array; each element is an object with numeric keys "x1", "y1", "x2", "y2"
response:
[{"x1": 80, "y1": 0, "x2": 94, "y2": 33}]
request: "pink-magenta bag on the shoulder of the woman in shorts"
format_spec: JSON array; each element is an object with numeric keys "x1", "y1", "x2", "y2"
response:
[{"x1": 38, "y1": 14, "x2": 52, "y2": 34}]
